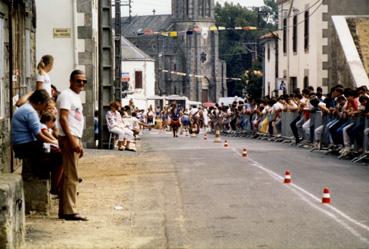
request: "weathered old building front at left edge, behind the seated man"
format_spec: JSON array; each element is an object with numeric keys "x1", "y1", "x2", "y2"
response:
[{"x1": 0, "y1": 0, "x2": 36, "y2": 173}]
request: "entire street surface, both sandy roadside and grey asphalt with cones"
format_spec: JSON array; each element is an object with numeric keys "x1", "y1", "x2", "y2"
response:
[{"x1": 26, "y1": 130, "x2": 369, "y2": 248}]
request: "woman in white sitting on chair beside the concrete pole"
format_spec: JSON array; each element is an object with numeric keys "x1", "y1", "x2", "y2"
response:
[{"x1": 106, "y1": 101, "x2": 135, "y2": 151}]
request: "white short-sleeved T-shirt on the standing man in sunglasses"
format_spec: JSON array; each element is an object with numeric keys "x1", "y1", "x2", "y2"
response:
[{"x1": 56, "y1": 88, "x2": 84, "y2": 138}]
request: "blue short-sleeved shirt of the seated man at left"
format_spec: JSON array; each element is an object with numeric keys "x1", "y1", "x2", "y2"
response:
[{"x1": 12, "y1": 103, "x2": 41, "y2": 145}]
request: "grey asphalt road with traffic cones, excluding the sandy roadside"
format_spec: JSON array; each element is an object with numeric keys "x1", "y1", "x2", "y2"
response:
[{"x1": 143, "y1": 131, "x2": 369, "y2": 249}]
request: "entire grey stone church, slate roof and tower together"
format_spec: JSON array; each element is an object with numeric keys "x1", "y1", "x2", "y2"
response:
[{"x1": 122, "y1": 0, "x2": 227, "y2": 102}]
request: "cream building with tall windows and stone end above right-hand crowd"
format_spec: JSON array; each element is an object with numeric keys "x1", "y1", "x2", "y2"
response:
[{"x1": 264, "y1": 0, "x2": 369, "y2": 95}]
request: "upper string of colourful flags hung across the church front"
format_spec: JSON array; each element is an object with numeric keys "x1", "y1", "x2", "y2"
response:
[{"x1": 137, "y1": 25, "x2": 258, "y2": 37}]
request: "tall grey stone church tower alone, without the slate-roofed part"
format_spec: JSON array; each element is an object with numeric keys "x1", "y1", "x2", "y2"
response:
[{"x1": 168, "y1": 0, "x2": 227, "y2": 102}]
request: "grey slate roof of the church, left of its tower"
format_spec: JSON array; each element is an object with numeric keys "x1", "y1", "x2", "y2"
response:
[{"x1": 122, "y1": 15, "x2": 173, "y2": 37}]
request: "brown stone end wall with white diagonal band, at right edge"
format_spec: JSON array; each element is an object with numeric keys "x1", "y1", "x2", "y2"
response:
[{"x1": 322, "y1": 0, "x2": 369, "y2": 87}]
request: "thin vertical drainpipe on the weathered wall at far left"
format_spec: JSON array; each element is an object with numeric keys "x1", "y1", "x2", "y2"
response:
[{"x1": 8, "y1": 0, "x2": 14, "y2": 173}]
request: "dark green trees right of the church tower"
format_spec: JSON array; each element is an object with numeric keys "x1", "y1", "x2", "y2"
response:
[{"x1": 215, "y1": 0, "x2": 277, "y2": 97}]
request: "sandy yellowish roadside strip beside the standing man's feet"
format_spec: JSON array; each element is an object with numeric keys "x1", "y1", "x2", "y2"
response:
[{"x1": 25, "y1": 140, "x2": 184, "y2": 249}]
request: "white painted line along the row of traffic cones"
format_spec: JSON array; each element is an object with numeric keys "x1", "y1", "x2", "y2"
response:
[{"x1": 232, "y1": 148, "x2": 369, "y2": 245}]
